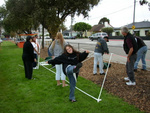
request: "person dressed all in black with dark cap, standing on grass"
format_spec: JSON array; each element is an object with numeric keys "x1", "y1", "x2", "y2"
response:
[{"x1": 22, "y1": 36, "x2": 34, "y2": 79}]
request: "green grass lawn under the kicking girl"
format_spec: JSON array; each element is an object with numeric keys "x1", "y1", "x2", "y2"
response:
[{"x1": 0, "y1": 41, "x2": 141, "y2": 113}]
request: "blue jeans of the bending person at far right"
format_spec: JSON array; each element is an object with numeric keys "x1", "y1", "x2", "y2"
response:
[{"x1": 134, "y1": 46, "x2": 147, "y2": 70}]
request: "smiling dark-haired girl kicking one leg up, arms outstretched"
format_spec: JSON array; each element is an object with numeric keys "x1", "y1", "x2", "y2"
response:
[{"x1": 47, "y1": 45, "x2": 89, "y2": 102}]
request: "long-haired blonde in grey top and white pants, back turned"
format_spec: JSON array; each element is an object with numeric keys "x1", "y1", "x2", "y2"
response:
[{"x1": 49, "y1": 32, "x2": 68, "y2": 87}]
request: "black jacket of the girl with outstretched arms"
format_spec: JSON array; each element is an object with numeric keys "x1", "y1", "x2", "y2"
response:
[{"x1": 48, "y1": 52, "x2": 88, "y2": 74}]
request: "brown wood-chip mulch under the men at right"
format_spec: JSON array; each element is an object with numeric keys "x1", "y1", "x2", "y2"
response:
[{"x1": 80, "y1": 58, "x2": 150, "y2": 112}]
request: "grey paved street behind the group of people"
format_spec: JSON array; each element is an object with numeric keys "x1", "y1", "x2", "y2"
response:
[{"x1": 39, "y1": 39, "x2": 150, "y2": 69}]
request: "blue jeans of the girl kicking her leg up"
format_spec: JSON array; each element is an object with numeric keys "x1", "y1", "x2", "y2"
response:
[{"x1": 66, "y1": 65, "x2": 76, "y2": 100}]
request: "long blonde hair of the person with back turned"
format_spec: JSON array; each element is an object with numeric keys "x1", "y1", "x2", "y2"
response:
[{"x1": 52, "y1": 32, "x2": 64, "y2": 49}]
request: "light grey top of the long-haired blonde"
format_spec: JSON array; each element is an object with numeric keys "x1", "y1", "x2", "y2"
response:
[{"x1": 49, "y1": 40, "x2": 67, "y2": 57}]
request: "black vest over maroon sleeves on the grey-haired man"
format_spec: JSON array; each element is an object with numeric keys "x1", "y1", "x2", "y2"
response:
[{"x1": 123, "y1": 33, "x2": 138, "y2": 54}]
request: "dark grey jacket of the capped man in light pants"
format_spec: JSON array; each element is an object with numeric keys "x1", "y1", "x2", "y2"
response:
[{"x1": 94, "y1": 38, "x2": 109, "y2": 54}]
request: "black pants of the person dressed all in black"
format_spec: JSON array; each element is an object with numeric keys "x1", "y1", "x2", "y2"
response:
[{"x1": 23, "y1": 60, "x2": 33, "y2": 79}]
